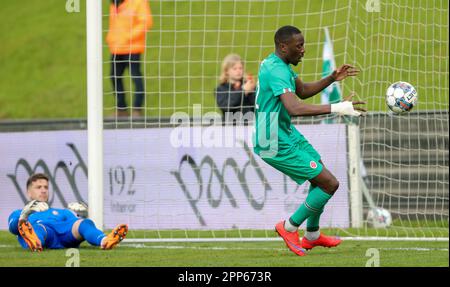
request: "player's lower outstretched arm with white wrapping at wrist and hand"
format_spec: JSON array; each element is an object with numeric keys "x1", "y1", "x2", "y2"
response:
[{"x1": 280, "y1": 92, "x2": 367, "y2": 116}]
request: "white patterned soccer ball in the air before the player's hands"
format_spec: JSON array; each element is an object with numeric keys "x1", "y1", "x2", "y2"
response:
[{"x1": 386, "y1": 82, "x2": 417, "y2": 114}]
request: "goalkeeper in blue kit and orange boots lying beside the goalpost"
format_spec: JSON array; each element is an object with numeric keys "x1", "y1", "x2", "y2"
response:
[{"x1": 8, "y1": 173, "x2": 128, "y2": 251}]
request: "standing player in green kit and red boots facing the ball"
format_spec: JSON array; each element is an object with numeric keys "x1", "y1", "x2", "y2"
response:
[{"x1": 254, "y1": 26, "x2": 366, "y2": 256}]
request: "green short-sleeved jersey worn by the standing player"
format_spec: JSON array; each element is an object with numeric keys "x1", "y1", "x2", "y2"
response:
[{"x1": 253, "y1": 53, "x2": 302, "y2": 158}]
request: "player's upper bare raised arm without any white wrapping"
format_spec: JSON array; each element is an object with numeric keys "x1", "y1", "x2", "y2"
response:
[{"x1": 295, "y1": 64, "x2": 359, "y2": 99}]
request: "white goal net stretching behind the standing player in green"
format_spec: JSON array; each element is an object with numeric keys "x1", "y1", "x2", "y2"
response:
[{"x1": 96, "y1": 0, "x2": 449, "y2": 240}]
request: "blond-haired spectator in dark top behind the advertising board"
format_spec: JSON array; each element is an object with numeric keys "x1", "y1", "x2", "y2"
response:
[{"x1": 216, "y1": 54, "x2": 255, "y2": 122}]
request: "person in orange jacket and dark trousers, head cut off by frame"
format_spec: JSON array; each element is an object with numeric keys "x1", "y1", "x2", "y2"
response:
[{"x1": 106, "y1": 0, "x2": 153, "y2": 117}]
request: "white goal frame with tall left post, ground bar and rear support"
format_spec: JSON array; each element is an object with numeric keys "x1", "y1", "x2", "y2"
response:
[{"x1": 85, "y1": 0, "x2": 448, "y2": 243}]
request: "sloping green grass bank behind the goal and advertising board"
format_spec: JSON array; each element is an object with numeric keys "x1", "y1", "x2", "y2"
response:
[{"x1": 0, "y1": 0, "x2": 449, "y2": 119}]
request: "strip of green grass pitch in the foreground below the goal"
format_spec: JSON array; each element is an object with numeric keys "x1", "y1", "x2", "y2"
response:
[{"x1": 0, "y1": 231, "x2": 449, "y2": 267}]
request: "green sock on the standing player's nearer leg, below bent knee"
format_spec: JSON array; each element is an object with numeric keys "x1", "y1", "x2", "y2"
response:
[{"x1": 289, "y1": 186, "x2": 331, "y2": 230}]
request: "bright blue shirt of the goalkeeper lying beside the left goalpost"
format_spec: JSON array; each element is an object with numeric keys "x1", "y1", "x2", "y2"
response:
[{"x1": 8, "y1": 208, "x2": 80, "y2": 251}]
